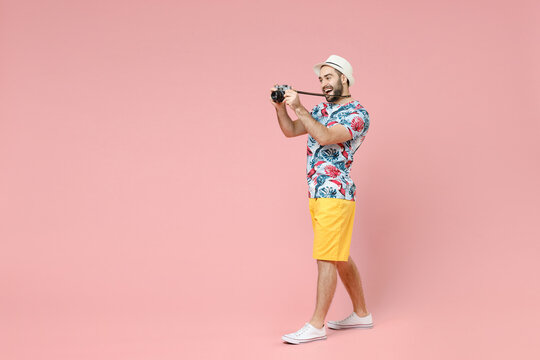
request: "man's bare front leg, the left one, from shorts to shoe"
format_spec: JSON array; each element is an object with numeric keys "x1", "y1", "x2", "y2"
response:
[{"x1": 310, "y1": 260, "x2": 337, "y2": 329}]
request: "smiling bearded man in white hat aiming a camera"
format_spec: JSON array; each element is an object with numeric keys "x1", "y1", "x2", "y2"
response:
[{"x1": 271, "y1": 55, "x2": 373, "y2": 344}]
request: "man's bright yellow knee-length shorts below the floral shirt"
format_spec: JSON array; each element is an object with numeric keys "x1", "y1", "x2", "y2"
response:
[{"x1": 309, "y1": 198, "x2": 356, "y2": 261}]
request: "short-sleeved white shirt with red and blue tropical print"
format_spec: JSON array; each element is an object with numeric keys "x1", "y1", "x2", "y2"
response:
[{"x1": 306, "y1": 100, "x2": 369, "y2": 201}]
